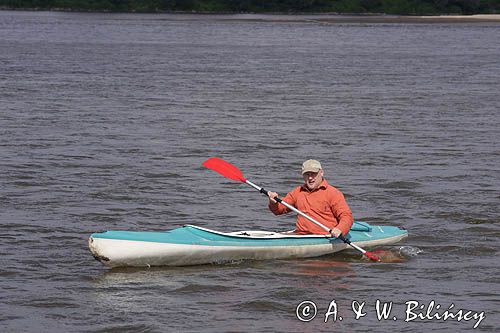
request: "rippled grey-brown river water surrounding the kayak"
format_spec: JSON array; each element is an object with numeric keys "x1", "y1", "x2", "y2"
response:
[{"x1": 0, "y1": 11, "x2": 500, "y2": 332}]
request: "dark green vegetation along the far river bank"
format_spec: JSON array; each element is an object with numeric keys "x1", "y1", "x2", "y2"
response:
[{"x1": 0, "y1": 0, "x2": 500, "y2": 15}]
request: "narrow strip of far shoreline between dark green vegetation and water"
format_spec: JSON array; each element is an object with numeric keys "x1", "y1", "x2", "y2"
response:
[{"x1": 0, "y1": 7, "x2": 500, "y2": 24}]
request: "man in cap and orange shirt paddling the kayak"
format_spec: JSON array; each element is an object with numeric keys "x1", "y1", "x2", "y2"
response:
[{"x1": 268, "y1": 160, "x2": 354, "y2": 237}]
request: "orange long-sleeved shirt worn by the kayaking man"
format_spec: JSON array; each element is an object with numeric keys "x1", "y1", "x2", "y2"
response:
[{"x1": 269, "y1": 179, "x2": 354, "y2": 235}]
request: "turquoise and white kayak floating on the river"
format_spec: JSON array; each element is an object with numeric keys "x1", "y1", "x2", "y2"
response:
[{"x1": 88, "y1": 222, "x2": 408, "y2": 268}]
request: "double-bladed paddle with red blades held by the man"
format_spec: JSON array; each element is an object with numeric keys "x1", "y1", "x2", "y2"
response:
[{"x1": 202, "y1": 157, "x2": 380, "y2": 261}]
